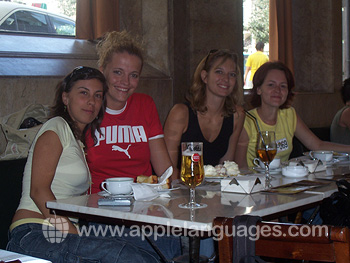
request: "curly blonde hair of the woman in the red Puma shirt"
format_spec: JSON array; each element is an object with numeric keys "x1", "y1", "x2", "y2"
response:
[{"x1": 96, "y1": 31, "x2": 143, "y2": 69}]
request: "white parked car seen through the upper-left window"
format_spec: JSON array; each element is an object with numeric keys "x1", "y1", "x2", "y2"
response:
[{"x1": 0, "y1": 1, "x2": 75, "y2": 36}]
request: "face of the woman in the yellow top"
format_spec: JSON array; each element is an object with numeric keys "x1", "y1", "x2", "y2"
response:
[{"x1": 257, "y1": 69, "x2": 288, "y2": 108}]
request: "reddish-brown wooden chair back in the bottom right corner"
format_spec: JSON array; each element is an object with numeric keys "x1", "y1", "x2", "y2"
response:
[{"x1": 213, "y1": 217, "x2": 350, "y2": 263}]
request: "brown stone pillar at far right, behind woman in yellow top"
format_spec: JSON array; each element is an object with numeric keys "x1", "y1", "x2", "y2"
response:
[{"x1": 292, "y1": 0, "x2": 343, "y2": 128}]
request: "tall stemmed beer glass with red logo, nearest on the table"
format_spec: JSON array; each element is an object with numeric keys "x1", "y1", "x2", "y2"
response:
[{"x1": 179, "y1": 142, "x2": 207, "y2": 209}]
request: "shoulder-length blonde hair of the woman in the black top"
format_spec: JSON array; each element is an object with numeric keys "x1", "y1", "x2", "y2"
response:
[{"x1": 186, "y1": 50, "x2": 243, "y2": 116}]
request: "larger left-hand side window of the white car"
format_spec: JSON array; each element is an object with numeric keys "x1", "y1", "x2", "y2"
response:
[{"x1": 0, "y1": 11, "x2": 50, "y2": 33}]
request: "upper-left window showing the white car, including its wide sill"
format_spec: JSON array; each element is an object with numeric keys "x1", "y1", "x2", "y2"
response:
[{"x1": 0, "y1": 0, "x2": 97, "y2": 77}]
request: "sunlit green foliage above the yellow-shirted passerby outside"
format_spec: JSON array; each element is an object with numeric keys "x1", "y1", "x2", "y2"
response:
[{"x1": 248, "y1": 0, "x2": 269, "y2": 43}]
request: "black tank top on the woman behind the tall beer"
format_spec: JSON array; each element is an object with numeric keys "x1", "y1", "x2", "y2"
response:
[{"x1": 179, "y1": 103, "x2": 233, "y2": 166}]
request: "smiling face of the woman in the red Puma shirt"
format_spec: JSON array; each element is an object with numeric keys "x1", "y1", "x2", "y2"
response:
[{"x1": 101, "y1": 52, "x2": 142, "y2": 110}]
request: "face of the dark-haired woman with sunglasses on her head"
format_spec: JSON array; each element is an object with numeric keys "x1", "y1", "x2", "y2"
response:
[{"x1": 62, "y1": 79, "x2": 103, "y2": 132}]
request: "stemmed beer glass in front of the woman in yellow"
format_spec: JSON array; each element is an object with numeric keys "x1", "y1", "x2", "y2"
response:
[{"x1": 258, "y1": 131, "x2": 277, "y2": 183}]
